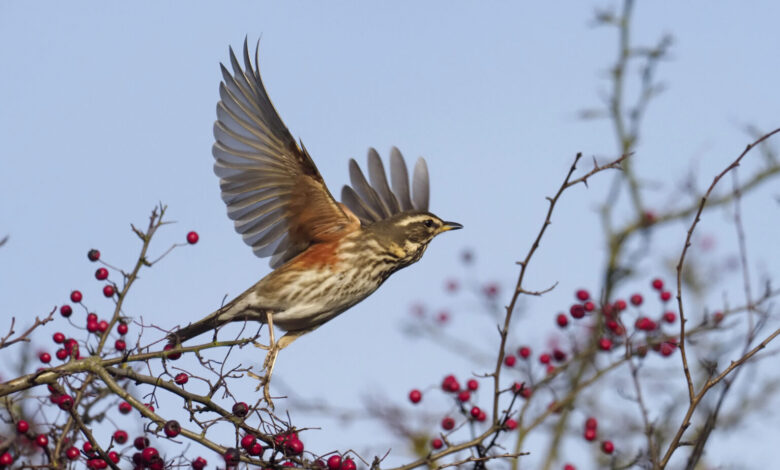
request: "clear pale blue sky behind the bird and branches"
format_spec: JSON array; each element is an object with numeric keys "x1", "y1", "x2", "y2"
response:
[{"x1": 0, "y1": 0, "x2": 780, "y2": 466}]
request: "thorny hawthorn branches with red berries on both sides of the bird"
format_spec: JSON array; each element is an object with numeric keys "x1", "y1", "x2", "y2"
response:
[{"x1": 0, "y1": 0, "x2": 780, "y2": 470}]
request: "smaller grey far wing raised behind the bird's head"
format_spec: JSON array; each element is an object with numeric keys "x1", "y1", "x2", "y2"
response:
[{"x1": 341, "y1": 147, "x2": 429, "y2": 224}]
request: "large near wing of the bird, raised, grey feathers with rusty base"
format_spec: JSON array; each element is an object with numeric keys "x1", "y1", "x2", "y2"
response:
[{"x1": 212, "y1": 40, "x2": 359, "y2": 268}]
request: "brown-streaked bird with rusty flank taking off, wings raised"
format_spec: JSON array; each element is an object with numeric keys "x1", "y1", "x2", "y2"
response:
[{"x1": 168, "y1": 39, "x2": 462, "y2": 406}]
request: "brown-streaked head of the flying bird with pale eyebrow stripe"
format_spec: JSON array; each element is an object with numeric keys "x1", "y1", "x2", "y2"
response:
[{"x1": 368, "y1": 211, "x2": 463, "y2": 264}]
